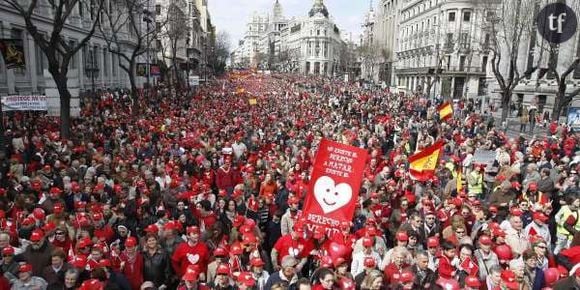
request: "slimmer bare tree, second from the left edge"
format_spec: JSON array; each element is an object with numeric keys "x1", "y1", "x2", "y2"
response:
[{"x1": 99, "y1": 0, "x2": 160, "y2": 104}]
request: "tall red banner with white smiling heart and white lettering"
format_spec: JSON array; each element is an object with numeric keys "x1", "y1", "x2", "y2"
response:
[{"x1": 302, "y1": 139, "x2": 368, "y2": 234}]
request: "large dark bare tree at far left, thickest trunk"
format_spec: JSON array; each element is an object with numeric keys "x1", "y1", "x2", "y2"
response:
[{"x1": 2, "y1": 0, "x2": 104, "y2": 138}]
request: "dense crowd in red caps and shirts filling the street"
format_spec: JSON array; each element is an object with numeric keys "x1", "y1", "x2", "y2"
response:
[{"x1": 0, "y1": 71, "x2": 580, "y2": 290}]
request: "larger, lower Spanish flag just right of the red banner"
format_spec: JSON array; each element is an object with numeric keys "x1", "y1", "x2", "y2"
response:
[{"x1": 409, "y1": 140, "x2": 444, "y2": 181}]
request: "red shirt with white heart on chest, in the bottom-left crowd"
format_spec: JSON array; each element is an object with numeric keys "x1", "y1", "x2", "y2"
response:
[{"x1": 171, "y1": 242, "x2": 209, "y2": 277}]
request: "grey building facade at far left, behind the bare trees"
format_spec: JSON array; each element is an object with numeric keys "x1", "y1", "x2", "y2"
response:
[{"x1": 0, "y1": 2, "x2": 145, "y2": 96}]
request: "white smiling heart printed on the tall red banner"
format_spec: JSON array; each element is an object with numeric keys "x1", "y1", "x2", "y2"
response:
[{"x1": 314, "y1": 176, "x2": 352, "y2": 214}]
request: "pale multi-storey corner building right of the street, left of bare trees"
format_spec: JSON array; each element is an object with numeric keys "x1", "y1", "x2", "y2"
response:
[{"x1": 395, "y1": 0, "x2": 490, "y2": 99}]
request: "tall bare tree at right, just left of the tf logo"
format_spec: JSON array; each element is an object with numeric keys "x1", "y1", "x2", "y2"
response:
[{"x1": 481, "y1": 0, "x2": 542, "y2": 121}]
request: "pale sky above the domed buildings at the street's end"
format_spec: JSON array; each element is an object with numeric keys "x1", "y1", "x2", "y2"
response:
[{"x1": 208, "y1": 0, "x2": 376, "y2": 49}]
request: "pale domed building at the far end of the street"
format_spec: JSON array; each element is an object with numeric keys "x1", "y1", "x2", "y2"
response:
[{"x1": 232, "y1": 0, "x2": 344, "y2": 76}]
